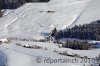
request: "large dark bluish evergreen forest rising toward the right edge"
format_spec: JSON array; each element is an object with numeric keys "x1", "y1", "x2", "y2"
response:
[{"x1": 52, "y1": 20, "x2": 100, "y2": 40}]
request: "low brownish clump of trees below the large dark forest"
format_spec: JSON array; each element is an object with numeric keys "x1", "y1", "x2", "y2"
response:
[{"x1": 62, "y1": 41, "x2": 92, "y2": 50}]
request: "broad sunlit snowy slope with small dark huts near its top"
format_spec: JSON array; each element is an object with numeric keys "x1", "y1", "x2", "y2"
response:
[{"x1": 0, "y1": 0, "x2": 89, "y2": 37}]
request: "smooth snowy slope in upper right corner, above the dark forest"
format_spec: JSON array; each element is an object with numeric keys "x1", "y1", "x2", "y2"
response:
[{"x1": 74, "y1": 0, "x2": 100, "y2": 25}]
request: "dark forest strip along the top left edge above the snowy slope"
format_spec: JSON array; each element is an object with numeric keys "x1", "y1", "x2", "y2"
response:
[{"x1": 0, "y1": 0, "x2": 50, "y2": 9}]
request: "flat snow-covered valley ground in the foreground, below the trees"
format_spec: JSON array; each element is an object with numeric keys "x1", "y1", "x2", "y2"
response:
[{"x1": 0, "y1": 41, "x2": 100, "y2": 66}]
